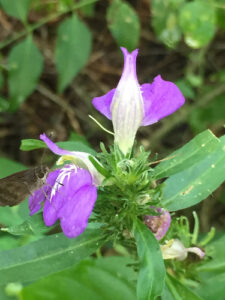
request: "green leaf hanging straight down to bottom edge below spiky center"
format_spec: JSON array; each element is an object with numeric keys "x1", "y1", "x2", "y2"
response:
[{"x1": 134, "y1": 219, "x2": 166, "y2": 300}]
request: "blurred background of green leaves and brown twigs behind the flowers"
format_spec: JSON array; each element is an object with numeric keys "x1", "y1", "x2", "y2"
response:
[{"x1": 0, "y1": 0, "x2": 225, "y2": 236}]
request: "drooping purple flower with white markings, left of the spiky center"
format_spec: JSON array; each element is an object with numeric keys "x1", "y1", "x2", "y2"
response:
[{"x1": 29, "y1": 134, "x2": 103, "y2": 238}]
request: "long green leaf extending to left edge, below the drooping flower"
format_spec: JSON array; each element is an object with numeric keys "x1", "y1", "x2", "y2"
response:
[{"x1": 0, "y1": 229, "x2": 104, "y2": 285}]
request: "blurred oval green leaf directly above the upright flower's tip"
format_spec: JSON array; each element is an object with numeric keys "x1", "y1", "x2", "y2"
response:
[{"x1": 107, "y1": 0, "x2": 140, "y2": 51}]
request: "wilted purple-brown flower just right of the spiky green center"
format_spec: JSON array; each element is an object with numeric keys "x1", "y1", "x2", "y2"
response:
[{"x1": 144, "y1": 208, "x2": 171, "y2": 240}]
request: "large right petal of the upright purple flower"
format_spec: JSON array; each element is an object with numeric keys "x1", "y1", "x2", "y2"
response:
[{"x1": 141, "y1": 75, "x2": 185, "y2": 126}]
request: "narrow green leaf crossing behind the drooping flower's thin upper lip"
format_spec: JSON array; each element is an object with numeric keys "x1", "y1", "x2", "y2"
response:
[{"x1": 20, "y1": 139, "x2": 96, "y2": 155}]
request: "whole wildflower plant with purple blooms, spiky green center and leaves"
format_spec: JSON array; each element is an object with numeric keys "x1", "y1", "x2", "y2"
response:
[{"x1": 0, "y1": 48, "x2": 225, "y2": 300}]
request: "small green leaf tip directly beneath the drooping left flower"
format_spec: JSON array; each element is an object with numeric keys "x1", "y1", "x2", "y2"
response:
[{"x1": 1, "y1": 213, "x2": 51, "y2": 235}]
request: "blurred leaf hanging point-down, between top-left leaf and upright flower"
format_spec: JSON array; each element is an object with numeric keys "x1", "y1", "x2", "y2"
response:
[{"x1": 55, "y1": 14, "x2": 91, "y2": 92}]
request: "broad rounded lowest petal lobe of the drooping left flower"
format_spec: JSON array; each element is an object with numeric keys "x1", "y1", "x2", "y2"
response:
[{"x1": 59, "y1": 185, "x2": 97, "y2": 238}]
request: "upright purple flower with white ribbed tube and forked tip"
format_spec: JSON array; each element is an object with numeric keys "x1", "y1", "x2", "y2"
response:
[{"x1": 92, "y1": 47, "x2": 185, "y2": 154}]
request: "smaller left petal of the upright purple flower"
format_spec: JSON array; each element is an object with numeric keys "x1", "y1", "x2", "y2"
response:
[{"x1": 92, "y1": 89, "x2": 116, "y2": 120}]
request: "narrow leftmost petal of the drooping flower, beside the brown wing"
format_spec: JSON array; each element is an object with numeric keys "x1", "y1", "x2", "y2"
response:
[{"x1": 29, "y1": 169, "x2": 60, "y2": 216}]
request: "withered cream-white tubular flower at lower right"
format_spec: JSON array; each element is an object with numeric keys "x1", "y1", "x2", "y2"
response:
[{"x1": 160, "y1": 239, "x2": 205, "y2": 260}]
